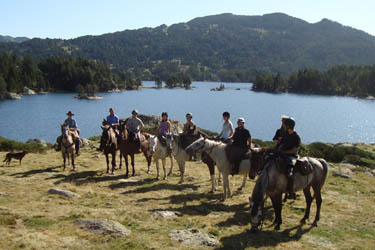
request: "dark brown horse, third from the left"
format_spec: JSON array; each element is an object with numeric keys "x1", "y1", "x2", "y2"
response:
[{"x1": 119, "y1": 129, "x2": 152, "y2": 178}]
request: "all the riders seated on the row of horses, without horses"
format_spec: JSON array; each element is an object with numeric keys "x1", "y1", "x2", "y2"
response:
[{"x1": 58, "y1": 108, "x2": 301, "y2": 195}]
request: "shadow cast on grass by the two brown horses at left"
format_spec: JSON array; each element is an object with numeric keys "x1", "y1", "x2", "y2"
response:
[{"x1": 46, "y1": 171, "x2": 128, "y2": 185}]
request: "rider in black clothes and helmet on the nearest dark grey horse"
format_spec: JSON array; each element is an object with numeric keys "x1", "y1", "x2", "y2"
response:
[{"x1": 279, "y1": 117, "x2": 301, "y2": 193}]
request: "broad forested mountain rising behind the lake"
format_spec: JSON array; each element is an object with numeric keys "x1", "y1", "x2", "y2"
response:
[{"x1": 0, "y1": 13, "x2": 375, "y2": 80}]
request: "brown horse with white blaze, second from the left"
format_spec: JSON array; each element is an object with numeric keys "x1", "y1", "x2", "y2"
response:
[{"x1": 100, "y1": 125, "x2": 118, "y2": 174}]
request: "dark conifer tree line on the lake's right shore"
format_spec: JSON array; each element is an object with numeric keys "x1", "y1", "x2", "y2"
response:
[{"x1": 253, "y1": 65, "x2": 375, "y2": 97}]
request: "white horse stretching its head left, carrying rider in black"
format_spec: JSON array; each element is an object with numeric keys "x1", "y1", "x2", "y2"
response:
[{"x1": 186, "y1": 138, "x2": 256, "y2": 200}]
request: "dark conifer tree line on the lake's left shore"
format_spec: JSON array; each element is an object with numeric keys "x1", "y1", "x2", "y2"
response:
[{"x1": 0, "y1": 53, "x2": 142, "y2": 97}]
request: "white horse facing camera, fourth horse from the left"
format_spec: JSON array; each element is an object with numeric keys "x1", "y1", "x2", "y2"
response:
[{"x1": 147, "y1": 135, "x2": 173, "y2": 180}]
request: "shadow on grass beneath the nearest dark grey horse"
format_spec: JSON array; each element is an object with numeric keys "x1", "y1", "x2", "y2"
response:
[{"x1": 216, "y1": 225, "x2": 313, "y2": 250}]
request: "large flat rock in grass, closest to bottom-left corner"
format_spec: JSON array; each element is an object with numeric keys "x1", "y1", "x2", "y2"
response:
[{"x1": 73, "y1": 219, "x2": 131, "y2": 237}]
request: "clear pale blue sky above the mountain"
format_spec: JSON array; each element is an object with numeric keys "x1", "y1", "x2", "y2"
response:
[{"x1": 0, "y1": 0, "x2": 375, "y2": 39}]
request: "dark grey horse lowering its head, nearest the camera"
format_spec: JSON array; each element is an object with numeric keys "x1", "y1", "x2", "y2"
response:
[{"x1": 250, "y1": 153, "x2": 328, "y2": 232}]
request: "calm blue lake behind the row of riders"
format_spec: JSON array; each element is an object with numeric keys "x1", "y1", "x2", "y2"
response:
[{"x1": 0, "y1": 82, "x2": 375, "y2": 143}]
